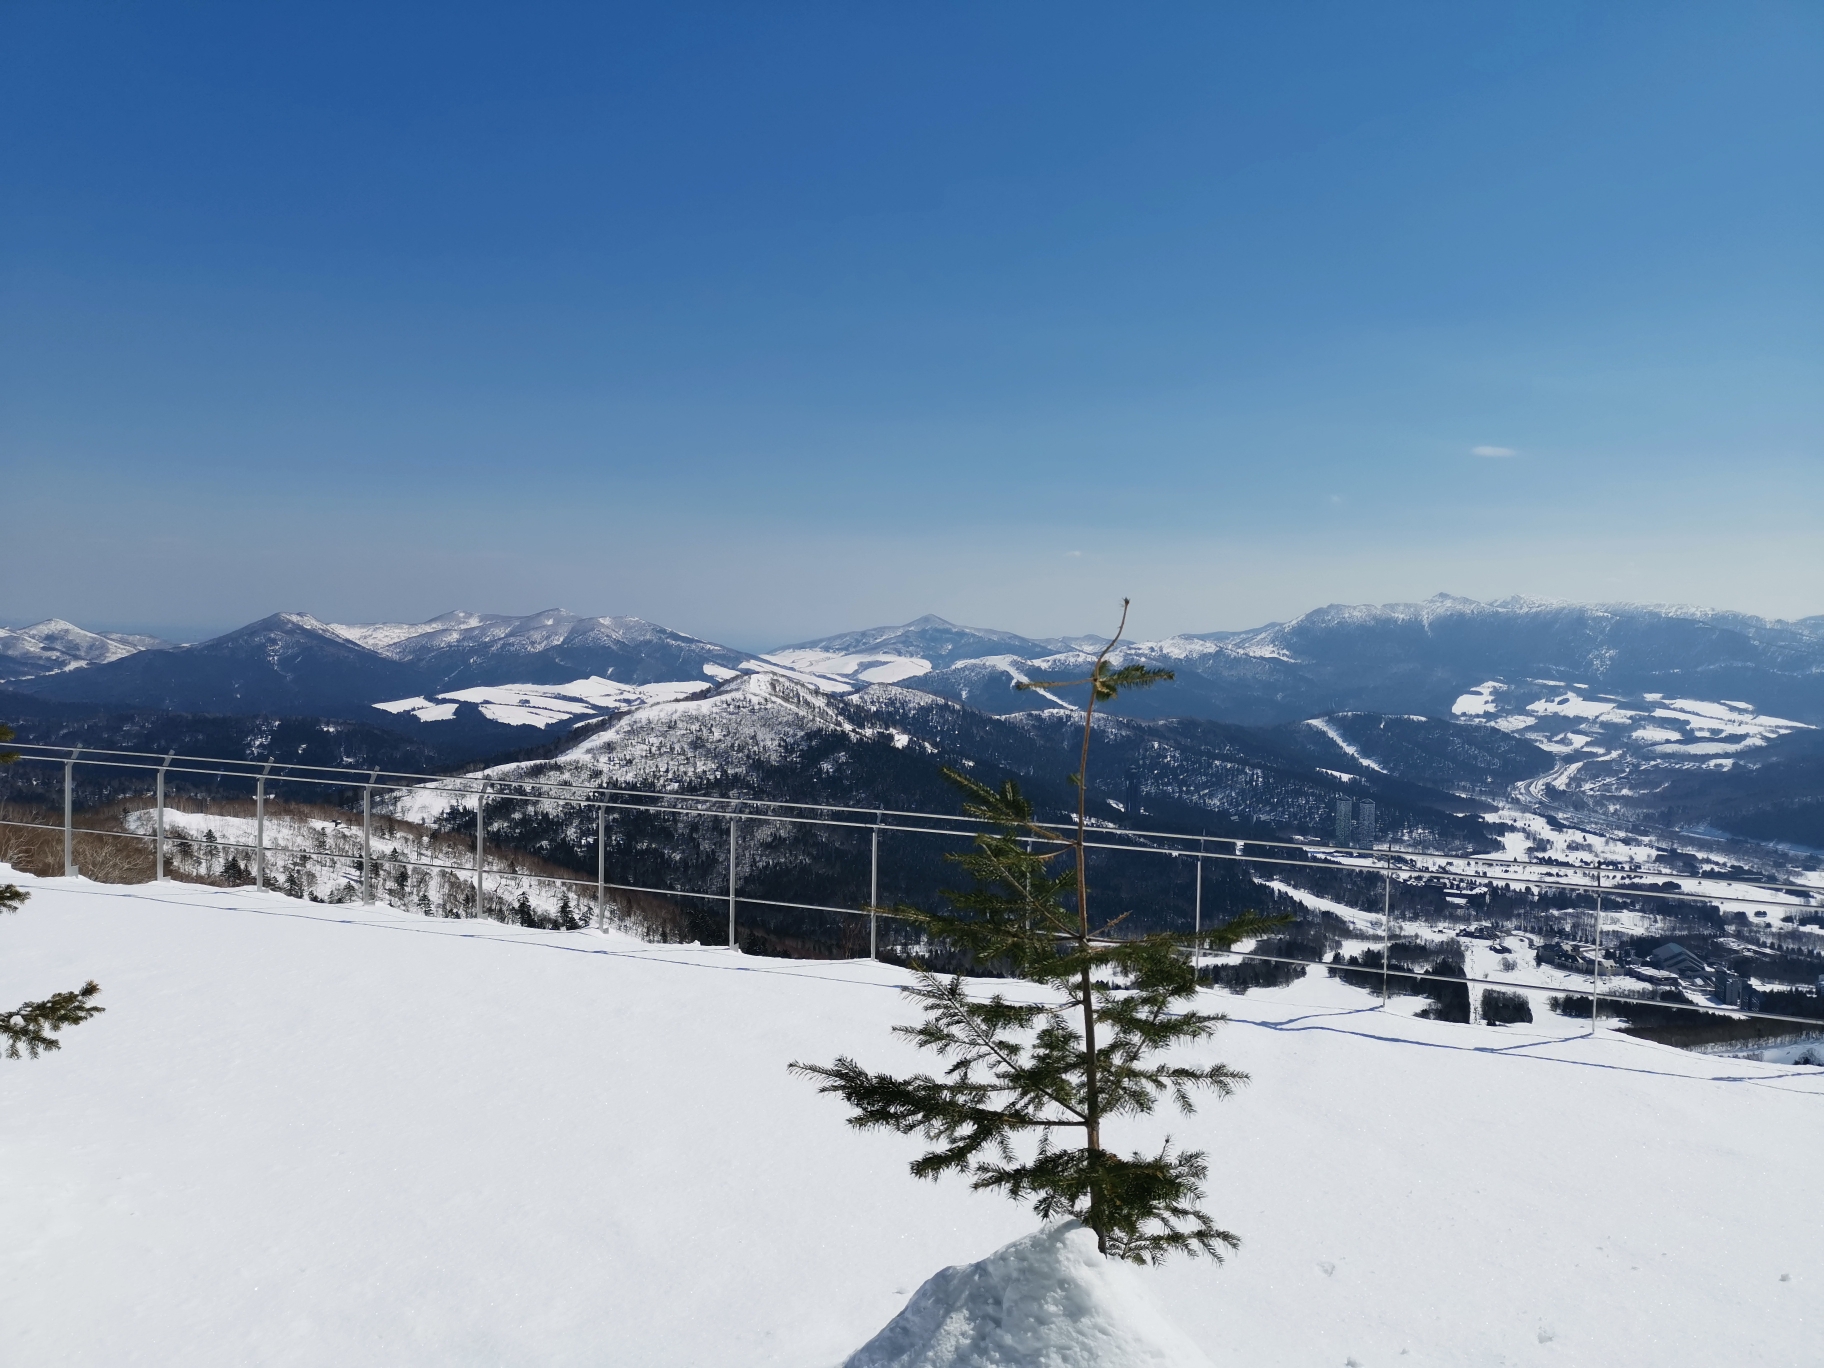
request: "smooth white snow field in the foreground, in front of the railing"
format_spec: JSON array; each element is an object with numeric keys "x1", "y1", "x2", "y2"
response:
[{"x1": 0, "y1": 877, "x2": 1824, "y2": 1368}]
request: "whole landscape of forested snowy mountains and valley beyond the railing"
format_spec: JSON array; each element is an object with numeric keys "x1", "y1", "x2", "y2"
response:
[{"x1": 0, "y1": 598, "x2": 1824, "y2": 1049}]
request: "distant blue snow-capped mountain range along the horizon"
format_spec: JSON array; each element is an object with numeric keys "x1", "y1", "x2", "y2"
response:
[{"x1": 14, "y1": 595, "x2": 1824, "y2": 726}]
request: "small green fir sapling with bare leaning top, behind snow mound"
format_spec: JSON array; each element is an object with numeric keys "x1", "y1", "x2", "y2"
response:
[{"x1": 792, "y1": 600, "x2": 1284, "y2": 1262}]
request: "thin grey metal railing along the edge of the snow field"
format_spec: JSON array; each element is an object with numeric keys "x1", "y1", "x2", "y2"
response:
[{"x1": 0, "y1": 742, "x2": 1824, "y2": 1032}]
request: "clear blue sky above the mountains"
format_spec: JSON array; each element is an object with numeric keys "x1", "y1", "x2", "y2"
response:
[{"x1": 0, "y1": 0, "x2": 1824, "y2": 646}]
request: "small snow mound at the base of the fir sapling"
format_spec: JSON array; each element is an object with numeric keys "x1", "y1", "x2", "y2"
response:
[{"x1": 843, "y1": 1220, "x2": 1211, "y2": 1368}]
